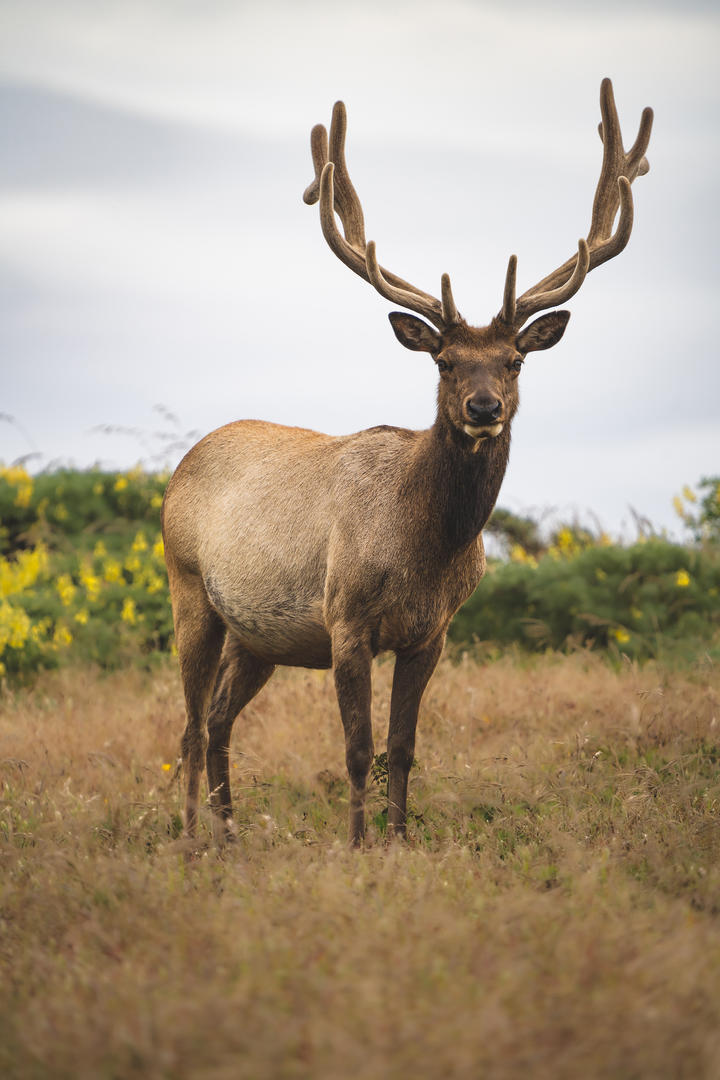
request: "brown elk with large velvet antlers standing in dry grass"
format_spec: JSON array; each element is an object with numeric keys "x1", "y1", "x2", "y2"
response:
[{"x1": 163, "y1": 79, "x2": 653, "y2": 847}]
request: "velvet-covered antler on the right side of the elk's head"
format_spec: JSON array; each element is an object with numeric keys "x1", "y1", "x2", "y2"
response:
[{"x1": 498, "y1": 79, "x2": 653, "y2": 327}]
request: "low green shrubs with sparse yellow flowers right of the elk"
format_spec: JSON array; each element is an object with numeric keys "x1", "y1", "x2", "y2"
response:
[{"x1": 450, "y1": 538, "x2": 720, "y2": 659}]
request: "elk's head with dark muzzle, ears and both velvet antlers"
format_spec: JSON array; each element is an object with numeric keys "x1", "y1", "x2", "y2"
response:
[{"x1": 303, "y1": 79, "x2": 653, "y2": 448}]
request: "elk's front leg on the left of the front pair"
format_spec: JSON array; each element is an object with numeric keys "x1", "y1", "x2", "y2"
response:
[{"x1": 332, "y1": 630, "x2": 373, "y2": 848}]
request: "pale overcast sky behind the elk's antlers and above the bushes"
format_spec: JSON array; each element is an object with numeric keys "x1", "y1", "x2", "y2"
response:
[{"x1": 0, "y1": 0, "x2": 720, "y2": 535}]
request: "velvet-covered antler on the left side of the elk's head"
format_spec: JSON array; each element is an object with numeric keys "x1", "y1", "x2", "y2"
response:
[{"x1": 302, "y1": 102, "x2": 460, "y2": 329}]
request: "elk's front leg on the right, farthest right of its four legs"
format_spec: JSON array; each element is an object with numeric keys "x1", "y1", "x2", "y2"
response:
[{"x1": 388, "y1": 630, "x2": 445, "y2": 839}]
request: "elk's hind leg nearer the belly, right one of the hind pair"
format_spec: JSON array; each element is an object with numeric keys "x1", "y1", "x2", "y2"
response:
[{"x1": 207, "y1": 634, "x2": 275, "y2": 847}]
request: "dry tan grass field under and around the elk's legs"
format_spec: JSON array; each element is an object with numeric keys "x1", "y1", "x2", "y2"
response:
[{"x1": 0, "y1": 657, "x2": 720, "y2": 1080}]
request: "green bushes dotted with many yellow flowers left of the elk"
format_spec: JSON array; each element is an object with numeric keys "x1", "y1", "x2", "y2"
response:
[{"x1": 0, "y1": 468, "x2": 173, "y2": 678}]
